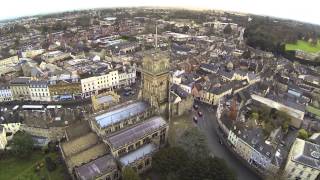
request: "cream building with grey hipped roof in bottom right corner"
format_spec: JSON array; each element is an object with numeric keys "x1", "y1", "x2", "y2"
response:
[{"x1": 285, "y1": 138, "x2": 320, "y2": 180}]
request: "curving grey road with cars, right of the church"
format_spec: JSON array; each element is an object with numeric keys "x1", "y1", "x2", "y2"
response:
[{"x1": 192, "y1": 103, "x2": 260, "y2": 180}]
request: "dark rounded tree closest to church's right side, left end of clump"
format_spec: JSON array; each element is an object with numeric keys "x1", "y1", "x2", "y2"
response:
[{"x1": 152, "y1": 147, "x2": 188, "y2": 178}]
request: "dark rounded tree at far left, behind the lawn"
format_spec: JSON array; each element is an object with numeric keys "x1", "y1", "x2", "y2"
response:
[{"x1": 11, "y1": 132, "x2": 34, "y2": 158}]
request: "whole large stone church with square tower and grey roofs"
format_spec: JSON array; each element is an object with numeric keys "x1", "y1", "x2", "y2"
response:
[{"x1": 60, "y1": 50, "x2": 170, "y2": 180}]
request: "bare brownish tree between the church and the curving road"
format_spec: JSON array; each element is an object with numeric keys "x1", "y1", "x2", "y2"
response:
[{"x1": 177, "y1": 128, "x2": 209, "y2": 157}]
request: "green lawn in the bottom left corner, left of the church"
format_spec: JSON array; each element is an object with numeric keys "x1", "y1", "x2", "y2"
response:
[{"x1": 0, "y1": 151, "x2": 64, "y2": 180}]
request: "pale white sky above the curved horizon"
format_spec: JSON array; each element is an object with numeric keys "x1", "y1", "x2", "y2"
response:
[{"x1": 0, "y1": 0, "x2": 320, "y2": 25}]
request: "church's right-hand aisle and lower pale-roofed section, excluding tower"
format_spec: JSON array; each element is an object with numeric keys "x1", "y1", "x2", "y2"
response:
[{"x1": 104, "y1": 116, "x2": 168, "y2": 173}]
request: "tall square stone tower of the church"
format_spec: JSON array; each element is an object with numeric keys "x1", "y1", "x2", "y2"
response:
[{"x1": 141, "y1": 50, "x2": 169, "y2": 115}]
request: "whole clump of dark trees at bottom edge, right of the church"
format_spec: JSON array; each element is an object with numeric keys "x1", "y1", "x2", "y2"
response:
[{"x1": 152, "y1": 147, "x2": 235, "y2": 180}]
